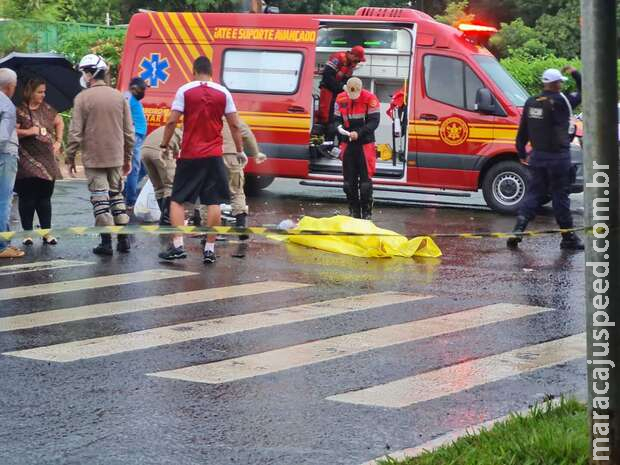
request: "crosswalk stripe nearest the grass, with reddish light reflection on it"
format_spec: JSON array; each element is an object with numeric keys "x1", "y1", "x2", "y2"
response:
[{"x1": 328, "y1": 333, "x2": 586, "y2": 408}]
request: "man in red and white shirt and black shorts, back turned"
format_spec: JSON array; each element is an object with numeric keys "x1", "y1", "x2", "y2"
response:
[{"x1": 159, "y1": 56, "x2": 247, "y2": 263}]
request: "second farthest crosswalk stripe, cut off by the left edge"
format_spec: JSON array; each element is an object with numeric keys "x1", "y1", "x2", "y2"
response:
[{"x1": 0, "y1": 270, "x2": 198, "y2": 300}]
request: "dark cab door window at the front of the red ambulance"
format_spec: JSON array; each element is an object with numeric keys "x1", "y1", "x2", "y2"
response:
[{"x1": 424, "y1": 55, "x2": 484, "y2": 111}]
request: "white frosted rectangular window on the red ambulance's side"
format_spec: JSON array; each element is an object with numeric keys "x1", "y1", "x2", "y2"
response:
[{"x1": 222, "y1": 49, "x2": 304, "y2": 95}]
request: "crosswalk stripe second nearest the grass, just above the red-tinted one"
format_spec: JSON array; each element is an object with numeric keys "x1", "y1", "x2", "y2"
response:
[{"x1": 152, "y1": 304, "x2": 549, "y2": 384}]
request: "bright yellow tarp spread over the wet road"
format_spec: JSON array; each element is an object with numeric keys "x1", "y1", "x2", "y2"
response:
[{"x1": 278, "y1": 215, "x2": 441, "y2": 258}]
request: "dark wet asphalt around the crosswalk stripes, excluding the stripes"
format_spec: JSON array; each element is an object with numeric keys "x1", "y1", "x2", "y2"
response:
[{"x1": 0, "y1": 181, "x2": 585, "y2": 465}]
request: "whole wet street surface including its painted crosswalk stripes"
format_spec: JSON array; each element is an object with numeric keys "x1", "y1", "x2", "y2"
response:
[{"x1": 0, "y1": 181, "x2": 585, "y2": 465}]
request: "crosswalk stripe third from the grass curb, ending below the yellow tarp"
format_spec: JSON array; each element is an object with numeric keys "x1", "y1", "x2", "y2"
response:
[{"x1": 4, "y1": 292, "x2": 430, "y2": 362}]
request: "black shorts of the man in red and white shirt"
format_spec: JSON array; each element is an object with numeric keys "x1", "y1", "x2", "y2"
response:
[{"x1": 171, "y1": 157, "x2": 230, "y2": 205}]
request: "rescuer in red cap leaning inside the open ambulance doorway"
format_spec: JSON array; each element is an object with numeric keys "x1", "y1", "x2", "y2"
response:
[{"x1": 317, "y1": 45, "x2": 366, "y2": 141}]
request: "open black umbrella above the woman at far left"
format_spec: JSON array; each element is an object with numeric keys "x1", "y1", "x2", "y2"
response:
[{"x1": 0, "y1": 53, "x2": 82, "y2": 112}]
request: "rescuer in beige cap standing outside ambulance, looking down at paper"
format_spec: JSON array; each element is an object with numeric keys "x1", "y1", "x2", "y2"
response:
[{"x1": 334, "y1": 77, "x2": 381, "y2": 220}]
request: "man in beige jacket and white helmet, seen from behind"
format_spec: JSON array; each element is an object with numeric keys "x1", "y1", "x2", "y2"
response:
[{"x1": 66, "y1": 54, "x2": 134, "y2": 255}]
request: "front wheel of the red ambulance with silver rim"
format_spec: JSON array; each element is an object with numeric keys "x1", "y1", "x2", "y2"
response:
[{"x1": 482, "y1": 160, "x2": 529, "y2": 215}]
